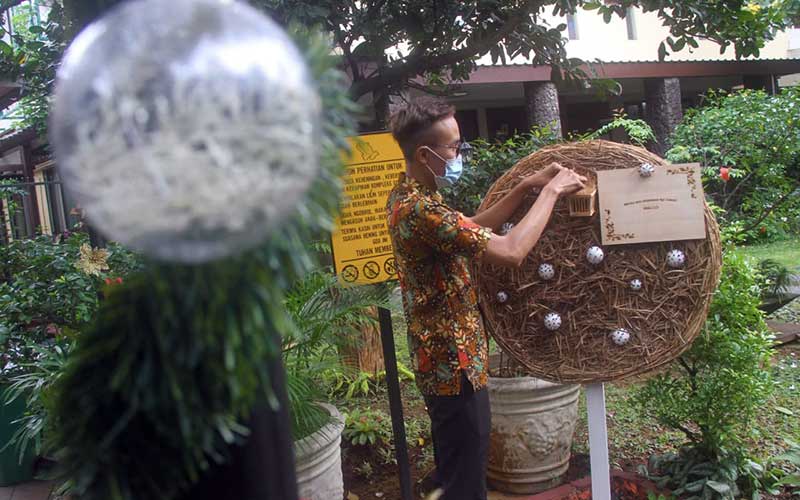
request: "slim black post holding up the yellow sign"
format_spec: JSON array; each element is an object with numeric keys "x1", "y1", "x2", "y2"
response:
[{"x1": 378, "y1": 307, "x2": 412, "y2": 500}]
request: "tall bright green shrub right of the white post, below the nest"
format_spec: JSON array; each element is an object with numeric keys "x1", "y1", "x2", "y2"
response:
[{"x1": 634, "y1": 250, "x2": 772, "y2": 498}]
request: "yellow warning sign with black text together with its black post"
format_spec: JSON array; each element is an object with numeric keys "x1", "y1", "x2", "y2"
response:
[{"x1": 331, "y1": 133, "x2": 412, "y2": 500}]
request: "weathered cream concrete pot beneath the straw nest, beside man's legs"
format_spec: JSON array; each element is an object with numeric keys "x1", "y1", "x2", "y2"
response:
[{"x1": 487, "y1": 368, "x2": 580, "y2": 494}]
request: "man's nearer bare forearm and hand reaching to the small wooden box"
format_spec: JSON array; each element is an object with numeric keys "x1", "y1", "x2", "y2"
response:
[{"x1": 483, "y1": 169, "x2": 586, "y2": 267}]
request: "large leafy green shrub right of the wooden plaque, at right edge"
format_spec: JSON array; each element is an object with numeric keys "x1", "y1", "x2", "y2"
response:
[{"x1": 667, "y1": 88, "x2": 800, "y2": 241}]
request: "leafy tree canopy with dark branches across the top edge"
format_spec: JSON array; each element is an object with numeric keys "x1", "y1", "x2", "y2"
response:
[{"x1": 0, "y1": 0, "x2": 800, "y2": 129}]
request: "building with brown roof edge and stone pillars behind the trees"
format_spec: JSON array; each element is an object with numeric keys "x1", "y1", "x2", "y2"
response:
[{"x1": 424, "y1": 9, "x2": 800, "y2": 153}]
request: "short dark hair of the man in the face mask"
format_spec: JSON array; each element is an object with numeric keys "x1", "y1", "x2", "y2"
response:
[{"x1": 389, "y1": 97, "x2": 456, "y2": 160}]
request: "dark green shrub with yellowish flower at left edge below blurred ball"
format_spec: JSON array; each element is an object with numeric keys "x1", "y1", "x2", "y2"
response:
[{"x1": 0, "y1": 232, "x2": 140, "y2": 380}]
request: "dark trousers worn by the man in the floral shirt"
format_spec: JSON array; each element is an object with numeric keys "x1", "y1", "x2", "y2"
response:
[{"x1": 425, "y1": 373, "x2": 491, "y2": 500}]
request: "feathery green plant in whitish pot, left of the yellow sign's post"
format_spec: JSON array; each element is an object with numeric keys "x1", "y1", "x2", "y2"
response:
[{"x1": 282, "y1": 268, "x2": 389, "y2": 500}]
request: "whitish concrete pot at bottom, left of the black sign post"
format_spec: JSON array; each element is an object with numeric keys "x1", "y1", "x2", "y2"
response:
[{"x1": 294, "y1": 403, "x2": 344, "y2": 500}]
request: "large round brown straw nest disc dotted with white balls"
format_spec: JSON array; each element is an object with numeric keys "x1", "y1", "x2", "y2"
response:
[{"x1": 476, "y1": 141, "x2": 721, "y2": 382}]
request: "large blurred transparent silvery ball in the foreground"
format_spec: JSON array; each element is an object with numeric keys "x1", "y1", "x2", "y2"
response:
[{"x1": 51, "y1": 0, "x2": 321, "y2": 263}]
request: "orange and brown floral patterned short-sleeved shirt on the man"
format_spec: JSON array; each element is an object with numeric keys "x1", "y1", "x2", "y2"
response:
[{"x1": 386, "y1": 175, "x2": 492, "y2": 396}]
